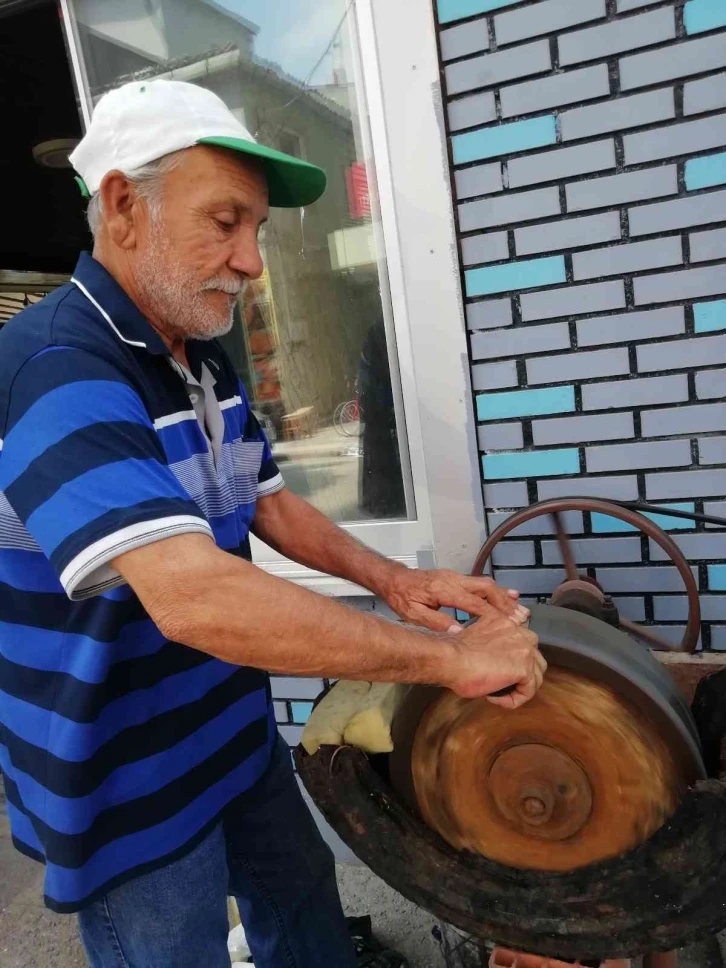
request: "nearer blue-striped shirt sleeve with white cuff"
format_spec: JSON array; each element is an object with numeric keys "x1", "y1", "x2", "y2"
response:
[{"x1": 0, "y1": 347, "x2": 212, "y2": 600}]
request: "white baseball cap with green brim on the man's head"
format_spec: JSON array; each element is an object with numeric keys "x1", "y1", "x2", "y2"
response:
[{"x1": 70, "y1": 80, "x2": 326, "y2": 208}]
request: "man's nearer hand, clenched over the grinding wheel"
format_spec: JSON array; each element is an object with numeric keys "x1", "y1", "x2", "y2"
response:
[{"x1": 446, "y1": 606, "x2": 547, "y2": 709}]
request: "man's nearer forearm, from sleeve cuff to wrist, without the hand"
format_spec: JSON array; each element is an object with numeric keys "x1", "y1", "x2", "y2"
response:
[{"x1": 117, "y1": 535, "x2": 456, "y2": 684}]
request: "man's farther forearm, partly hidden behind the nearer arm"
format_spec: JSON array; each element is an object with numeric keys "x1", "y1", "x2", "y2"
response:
[{"x1": 253, "y1": 489, "x2": 404, "y2": 596}]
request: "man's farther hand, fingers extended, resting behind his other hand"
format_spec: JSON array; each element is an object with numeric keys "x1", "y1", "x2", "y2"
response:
[{"x1": 383, "y1": 568, "x2": 529, "y2": 632}]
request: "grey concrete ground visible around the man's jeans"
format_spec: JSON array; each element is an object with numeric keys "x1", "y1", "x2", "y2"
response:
[{"x1": 0, "y1": 797, "x2": 725, "y2": 968}]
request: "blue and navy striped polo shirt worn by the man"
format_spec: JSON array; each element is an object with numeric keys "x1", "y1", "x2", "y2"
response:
[{"x1": 0, "y1": 255, "x2": 283, "y2": 911}]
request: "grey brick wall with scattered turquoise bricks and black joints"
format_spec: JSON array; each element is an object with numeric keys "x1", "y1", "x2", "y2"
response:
[{"x1": 435, "y1": 0, "x2": 726, "y2": 649}]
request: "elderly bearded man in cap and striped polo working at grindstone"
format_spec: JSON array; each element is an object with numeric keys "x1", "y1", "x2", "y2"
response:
[{"x1": 0, "y1": 80, "x2": 545, "y2": 968}]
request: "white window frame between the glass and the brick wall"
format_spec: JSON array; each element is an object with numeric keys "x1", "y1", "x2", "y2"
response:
[{"x1": 60, "y1": 0, "x2": 485, "y2": 595}]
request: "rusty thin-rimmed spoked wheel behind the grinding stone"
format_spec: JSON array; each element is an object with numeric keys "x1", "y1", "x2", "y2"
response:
[{"x1": 472, "y1": 497, "x2": 701, "y2": 652}]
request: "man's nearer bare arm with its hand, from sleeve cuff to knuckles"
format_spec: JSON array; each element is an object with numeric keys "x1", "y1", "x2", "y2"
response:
[{"x1": 112, "y1": 534, "x2": 544, "y2": 705}]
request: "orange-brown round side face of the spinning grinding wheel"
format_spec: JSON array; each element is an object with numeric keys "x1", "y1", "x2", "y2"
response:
[{"x1": 412, "y1": 668, "x2": 694, "y2": 871}]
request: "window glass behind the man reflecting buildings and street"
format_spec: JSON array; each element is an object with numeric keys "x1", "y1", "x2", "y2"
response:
[{"x1": 73, "y1": 0, "x2": 415, "y2": 521}]
